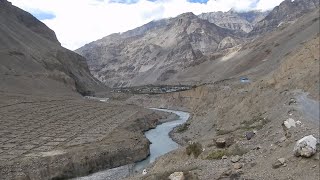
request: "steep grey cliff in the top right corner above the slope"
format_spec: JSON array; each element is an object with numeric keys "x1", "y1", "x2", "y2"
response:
[{"x1": 250, "y1": 0, "x2": 319, "y2": 36}]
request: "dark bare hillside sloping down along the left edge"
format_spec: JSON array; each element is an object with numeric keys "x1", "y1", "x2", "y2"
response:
[{"x1": 0, "y1": 0, "x2": 102, "y2": 95}]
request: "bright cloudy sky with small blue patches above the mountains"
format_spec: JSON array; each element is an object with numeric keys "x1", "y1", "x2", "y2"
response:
[{"x1": 9, "y1": 0, "x2": 283, "y2": 50}]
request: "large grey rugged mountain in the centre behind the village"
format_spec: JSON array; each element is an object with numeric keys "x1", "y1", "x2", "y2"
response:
[{"x1": 76, "y1": 13, "x2": 243, "y2": 87}]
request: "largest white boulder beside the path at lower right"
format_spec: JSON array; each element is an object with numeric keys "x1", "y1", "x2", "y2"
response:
[{"x1": 293, "y1": 135, "x2": 317, "y2": 157}]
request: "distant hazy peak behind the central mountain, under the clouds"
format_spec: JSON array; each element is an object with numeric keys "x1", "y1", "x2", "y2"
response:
[{"x1": 199, "y1": 10, "x2": 268, "y2": 33}]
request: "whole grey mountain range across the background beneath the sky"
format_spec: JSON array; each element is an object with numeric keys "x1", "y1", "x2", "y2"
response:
[{"x1": 76, "y1": 0, "x2": 319, "y2": 87}]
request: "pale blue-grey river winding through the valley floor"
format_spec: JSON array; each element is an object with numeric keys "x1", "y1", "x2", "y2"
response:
[{"x1": 75, "y1": 108, "x2": 190, "y2": 180}]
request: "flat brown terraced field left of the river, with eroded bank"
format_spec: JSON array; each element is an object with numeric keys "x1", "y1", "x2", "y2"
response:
[{"x1": 0, "y1": 95, "x2": 165, "y2": 179}]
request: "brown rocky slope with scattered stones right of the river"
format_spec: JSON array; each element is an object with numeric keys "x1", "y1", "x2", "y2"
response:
[{"x1": 121, "y1": 9, "x2": 320, "y2": 180}]
